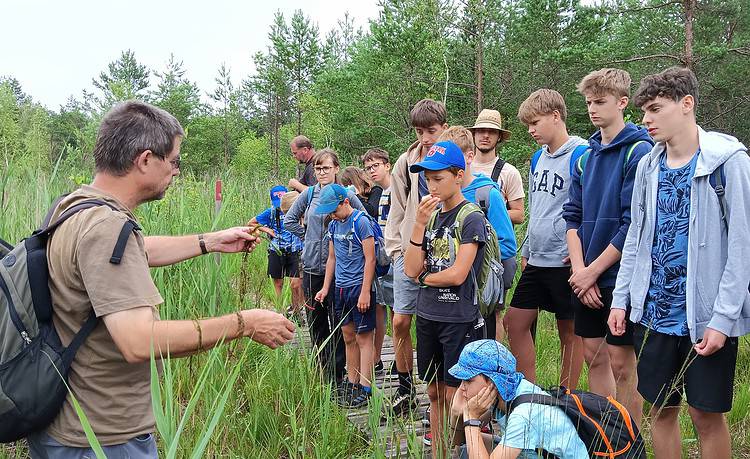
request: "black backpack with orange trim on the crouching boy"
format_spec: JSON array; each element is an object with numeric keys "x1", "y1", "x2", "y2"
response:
[{"x1": 508, "y1": 387, "x2": 646, "y2": 459}]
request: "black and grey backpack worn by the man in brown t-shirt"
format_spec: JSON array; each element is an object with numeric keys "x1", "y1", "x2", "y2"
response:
[{"x1": 0, "y1": 198, "x2": 140, "y2": 443}]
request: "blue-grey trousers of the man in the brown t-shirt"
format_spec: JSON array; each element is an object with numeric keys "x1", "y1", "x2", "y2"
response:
[{"x1": 27, "y1": 431, "x2": 159, "y2": 459}]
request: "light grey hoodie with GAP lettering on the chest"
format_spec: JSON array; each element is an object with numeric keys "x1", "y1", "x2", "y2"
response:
[{"x1": 521, "y1": 136, "x2": 588, "y2": 267}]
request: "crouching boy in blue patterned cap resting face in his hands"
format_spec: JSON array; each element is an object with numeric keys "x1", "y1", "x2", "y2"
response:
[{"x1": 448, "y1": 340, "x2": 589, "y2": 459}]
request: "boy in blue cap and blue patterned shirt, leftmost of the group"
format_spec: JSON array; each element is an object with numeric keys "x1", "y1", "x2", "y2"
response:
[{"x1": 248, "y1": 185, "x2": 303, "y2": 310}]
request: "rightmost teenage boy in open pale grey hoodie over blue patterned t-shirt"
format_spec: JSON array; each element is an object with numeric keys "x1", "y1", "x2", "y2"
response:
[{"x1": 609, "y1": 67, "x2": 750, "y2": 458}]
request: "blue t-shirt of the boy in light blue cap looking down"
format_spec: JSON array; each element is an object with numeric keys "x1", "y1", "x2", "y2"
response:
[{"x1": 326, "y1": 210, "x2": 373, "y2": 288}]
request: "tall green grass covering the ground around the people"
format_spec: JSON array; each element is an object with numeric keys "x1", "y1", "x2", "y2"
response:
[{"x1": 0, "y1": 170, "x2": 750, "y2": 458}]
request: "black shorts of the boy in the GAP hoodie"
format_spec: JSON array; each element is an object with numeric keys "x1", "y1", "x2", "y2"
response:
[{"x1": 510, "y1": 265, "x2": 574, "y2": 320}]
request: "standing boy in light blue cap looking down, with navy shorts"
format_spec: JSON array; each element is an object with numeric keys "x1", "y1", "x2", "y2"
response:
[{"x1": 315, "y1": 183, "x2": 375, "y2": 408}]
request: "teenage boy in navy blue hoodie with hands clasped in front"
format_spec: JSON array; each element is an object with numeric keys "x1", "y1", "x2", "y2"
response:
[{"x1": 563, "y1": 68, "x2": 653, "y2": 425}]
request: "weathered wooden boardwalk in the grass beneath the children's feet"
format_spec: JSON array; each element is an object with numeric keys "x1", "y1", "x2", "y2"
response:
[{"x1": 297, "y1": 324, "x2": 431, "y2": 458}]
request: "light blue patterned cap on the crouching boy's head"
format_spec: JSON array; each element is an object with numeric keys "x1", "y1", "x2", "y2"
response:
[{"x1": 448, "y1": 339, "x2": 523, "y2": 402}]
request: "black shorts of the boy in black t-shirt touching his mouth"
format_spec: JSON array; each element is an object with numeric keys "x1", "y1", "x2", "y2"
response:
[{"x1": 417, "y1": 315, "x2": 481, "y2": 387}]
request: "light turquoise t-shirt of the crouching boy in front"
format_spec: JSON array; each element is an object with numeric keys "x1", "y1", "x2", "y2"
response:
[{"x1": 496, "y1": 379, "x2": 589, "y2": 459}]
